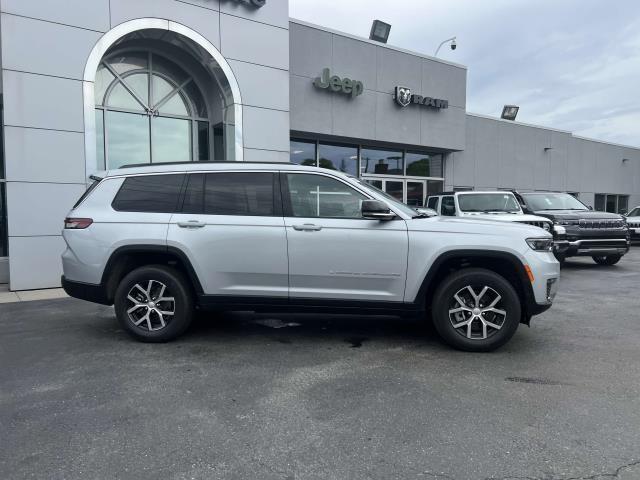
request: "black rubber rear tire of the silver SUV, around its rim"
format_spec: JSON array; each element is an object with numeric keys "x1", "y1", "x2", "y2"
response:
[{"x1": 114, "y1": 265, "x2": 194, "y2": 343}]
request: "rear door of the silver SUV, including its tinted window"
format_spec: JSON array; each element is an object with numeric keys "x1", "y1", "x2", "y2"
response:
[{"x1": 167, "y1": 171, "x2": 288, "y2": 297}]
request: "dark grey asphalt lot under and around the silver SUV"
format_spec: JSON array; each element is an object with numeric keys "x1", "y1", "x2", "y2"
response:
[{"x1": 0, "y1": 247, "x2": 640, "y2": 480}]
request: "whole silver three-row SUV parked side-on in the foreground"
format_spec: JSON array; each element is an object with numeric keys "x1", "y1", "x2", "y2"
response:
[{"x1": 62, "y1": 162, "x2": 560, "y2": 351}]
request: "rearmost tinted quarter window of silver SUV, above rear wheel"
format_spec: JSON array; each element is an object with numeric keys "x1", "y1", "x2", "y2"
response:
[{"x1": 111, "y1": 174, "x2": 185, "y2": 213}]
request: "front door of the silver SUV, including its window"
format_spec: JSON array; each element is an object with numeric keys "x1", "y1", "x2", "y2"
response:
[{"x1": 282, "y1": 173, "x2": 408, "y2": 302}]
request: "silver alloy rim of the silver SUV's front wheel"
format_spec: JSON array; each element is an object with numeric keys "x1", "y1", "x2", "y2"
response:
[{"x1": 449, "y1": 285, "x2": 507, "y2": 340}]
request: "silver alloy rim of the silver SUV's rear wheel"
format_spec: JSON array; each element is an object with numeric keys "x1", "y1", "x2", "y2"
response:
[{"x1": 127, "y1": 280, "x2": 176, "y2": 332}]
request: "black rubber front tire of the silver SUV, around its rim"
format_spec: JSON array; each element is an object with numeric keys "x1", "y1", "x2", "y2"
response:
[{"x1": 432, "y1": 268, "x2": 521, "y2": 352}]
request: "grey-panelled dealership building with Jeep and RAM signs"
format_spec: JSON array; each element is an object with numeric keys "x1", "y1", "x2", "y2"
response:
[{"x1": 0, "y1": 0, "x2": 640, "y2": 290}]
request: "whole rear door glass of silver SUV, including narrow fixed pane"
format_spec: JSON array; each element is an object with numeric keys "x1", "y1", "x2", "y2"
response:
[{"x1": 182, "y1": 172, "x2": 280, "y2": 217}]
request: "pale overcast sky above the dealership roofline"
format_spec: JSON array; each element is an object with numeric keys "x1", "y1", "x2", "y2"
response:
[{"x1": 289, "y1": 0, "x2": 640, "y2": 147}]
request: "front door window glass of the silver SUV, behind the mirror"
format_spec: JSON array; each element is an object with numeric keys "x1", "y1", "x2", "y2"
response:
[{"x1": 287, "y1": 174, "x2": 367, "y2": 218}]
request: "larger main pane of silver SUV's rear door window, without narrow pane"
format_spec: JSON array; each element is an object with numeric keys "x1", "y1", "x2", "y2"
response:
[{"x1": 204, "y1": 172, "x2": 274, "y2": 217}]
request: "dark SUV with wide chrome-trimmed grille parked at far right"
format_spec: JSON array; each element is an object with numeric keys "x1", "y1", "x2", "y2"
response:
[{"x1": 516, "y1": 192, "x2": 631, "y2": 265}]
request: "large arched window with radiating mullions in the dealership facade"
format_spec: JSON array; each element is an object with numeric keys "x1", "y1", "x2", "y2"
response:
[{"x1": 94, "y1": 52, "x2": 210, "y2": 169}]
